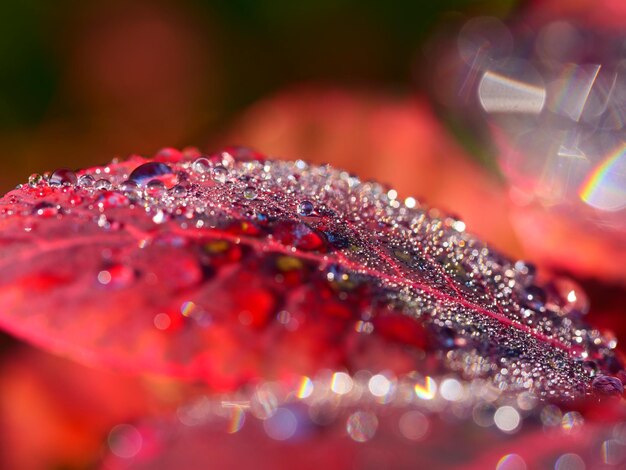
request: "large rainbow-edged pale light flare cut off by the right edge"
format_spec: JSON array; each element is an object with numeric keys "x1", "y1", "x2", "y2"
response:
[{"x1": 578, "y1": 143, "x2": 626, "y2": 211}]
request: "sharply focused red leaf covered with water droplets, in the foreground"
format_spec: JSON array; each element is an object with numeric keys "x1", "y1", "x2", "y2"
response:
[{"x1": 0, "y1": 148, "x2": 621, "y2": 399}]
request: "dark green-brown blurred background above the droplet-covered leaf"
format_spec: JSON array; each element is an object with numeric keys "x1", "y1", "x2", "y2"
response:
[{"x1": 0, "y1": 0, "x2": 519, "y2": 191}]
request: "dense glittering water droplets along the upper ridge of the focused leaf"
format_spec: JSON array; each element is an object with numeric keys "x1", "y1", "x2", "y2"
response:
[{"x1": 19, "y1": 148, "x2": 621, "y2": 399}]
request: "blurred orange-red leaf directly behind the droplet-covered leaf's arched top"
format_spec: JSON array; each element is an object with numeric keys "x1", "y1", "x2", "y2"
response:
[{"x1": 225, "y1": 85, "x2": 521, "y2": 256}]
